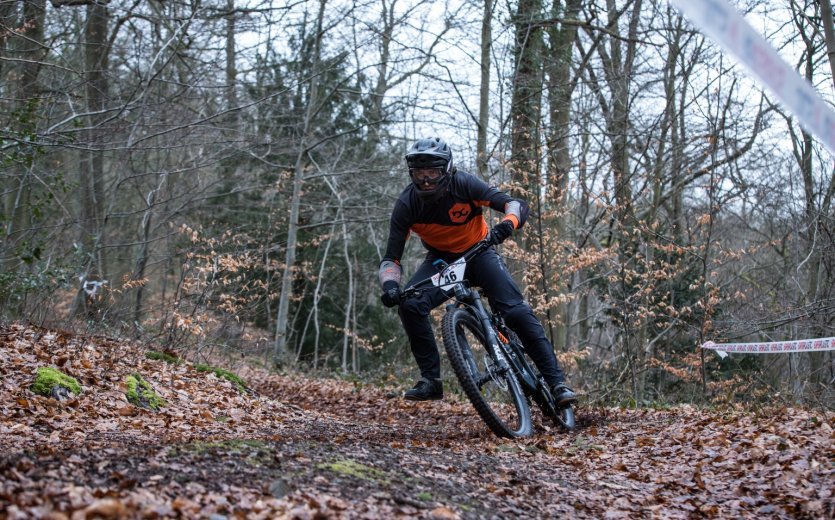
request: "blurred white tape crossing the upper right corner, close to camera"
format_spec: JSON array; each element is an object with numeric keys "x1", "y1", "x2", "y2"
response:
[{"x1": 670, "y1": 0, "x2": 835, "y2": 153}]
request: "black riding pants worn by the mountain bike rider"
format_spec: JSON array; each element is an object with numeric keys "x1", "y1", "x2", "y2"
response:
[{"x1": 399, "y1": 247, "x2": 565, "y2": 385}]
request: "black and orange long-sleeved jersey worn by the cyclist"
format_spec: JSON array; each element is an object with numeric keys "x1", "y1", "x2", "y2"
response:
[{"x1": 383, "y1": 171, "x2": 520, "y2": 264}]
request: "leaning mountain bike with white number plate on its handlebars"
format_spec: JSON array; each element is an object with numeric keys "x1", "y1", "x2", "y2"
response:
[{"x1": 401, "y1": 240, "x2": 575, "y2": 437}]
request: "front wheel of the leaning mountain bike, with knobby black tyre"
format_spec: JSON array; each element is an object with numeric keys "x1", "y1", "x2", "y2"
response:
[{"x1": 443, "y1": 308, "x2": 533, "y2": 437}]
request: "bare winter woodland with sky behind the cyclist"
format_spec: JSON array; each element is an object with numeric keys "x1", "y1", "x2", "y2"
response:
[{"x1": 0, "y1": 0, "x2": 835, "y2": 408}]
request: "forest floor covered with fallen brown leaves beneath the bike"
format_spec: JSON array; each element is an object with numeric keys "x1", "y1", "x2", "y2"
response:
[{"x1": 0, "y1": 324, "x2": 835, "y2": 520}]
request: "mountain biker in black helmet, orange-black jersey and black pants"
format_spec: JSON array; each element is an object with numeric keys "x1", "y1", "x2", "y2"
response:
[{"x1": 380, "y1": 137, "x2": 577, "y2": 405}]
